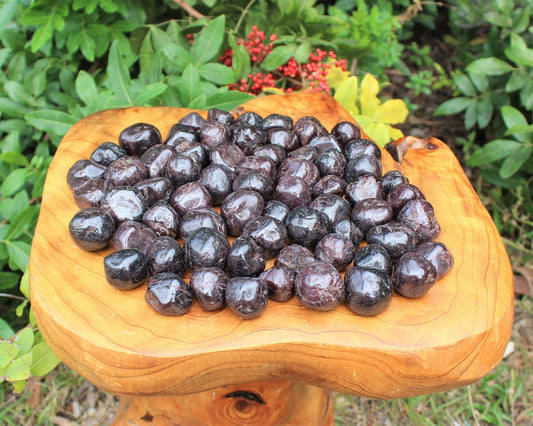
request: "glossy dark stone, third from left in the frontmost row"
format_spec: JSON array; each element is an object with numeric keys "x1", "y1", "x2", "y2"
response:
[{"x1": 226, "y1": 277, "x2": 268, "y2": 320}]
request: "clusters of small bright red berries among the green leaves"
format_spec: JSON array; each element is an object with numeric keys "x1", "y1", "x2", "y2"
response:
[{"x1": 220, "y1": 25, "x2": 347, "y2": 95}]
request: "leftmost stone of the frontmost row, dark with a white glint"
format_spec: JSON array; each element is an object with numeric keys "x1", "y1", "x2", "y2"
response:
[{"x1": 145, "y1": 272, "x2": 192, "y2": 316}]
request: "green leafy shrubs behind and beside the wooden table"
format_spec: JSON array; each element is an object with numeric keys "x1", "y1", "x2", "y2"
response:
[{"x1": 0, "y1": 0, "x2": 533, "y2": 390}]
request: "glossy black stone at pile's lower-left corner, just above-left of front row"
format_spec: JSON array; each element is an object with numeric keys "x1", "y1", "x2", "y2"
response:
[{"x1": 104, "y1": 249, "x2": 148, "y2": 290}]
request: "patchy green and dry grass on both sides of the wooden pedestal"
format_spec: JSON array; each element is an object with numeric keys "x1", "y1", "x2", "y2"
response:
[{"x1": 0, "y1": 297, "x2": 533, "y2": 426}]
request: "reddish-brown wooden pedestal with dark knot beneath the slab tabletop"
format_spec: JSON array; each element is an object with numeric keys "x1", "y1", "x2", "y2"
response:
[{"x1": 113, "y1": 380, "x2": 334, "y2": 426}]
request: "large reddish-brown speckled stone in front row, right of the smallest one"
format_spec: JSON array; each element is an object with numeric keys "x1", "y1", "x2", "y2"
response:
[{"x1": 294, "y1": 261, "x2": 344, "y2": 311}]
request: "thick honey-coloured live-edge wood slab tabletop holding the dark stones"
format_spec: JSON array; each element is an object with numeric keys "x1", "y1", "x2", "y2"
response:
[{"x1": 30, "y1": 94, "x2": 513, "y2": 408}]
